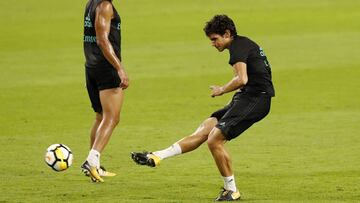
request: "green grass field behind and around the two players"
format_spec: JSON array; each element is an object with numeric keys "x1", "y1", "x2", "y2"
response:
[{"x1": 0, "y1": 0, "x2": 360, "y2": 202}]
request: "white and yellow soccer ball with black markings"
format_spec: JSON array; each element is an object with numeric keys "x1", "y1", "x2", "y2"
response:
[{"x1": 45, "y1": 144, "x2": 73, "y2": 171}]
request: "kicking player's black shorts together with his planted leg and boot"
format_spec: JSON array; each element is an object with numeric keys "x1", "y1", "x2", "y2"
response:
[{"x1": 208, "y1": 93, "x2": 271, "y2": 201}]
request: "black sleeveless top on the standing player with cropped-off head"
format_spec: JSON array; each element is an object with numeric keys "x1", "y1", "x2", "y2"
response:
[{"x1": 84, "y1": 0, "x2": 121, "y2": 68}]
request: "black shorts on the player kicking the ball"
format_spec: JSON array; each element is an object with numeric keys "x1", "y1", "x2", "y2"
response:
[{"x1": 211, "y1": 92, "x2": 271, "y2": 140}]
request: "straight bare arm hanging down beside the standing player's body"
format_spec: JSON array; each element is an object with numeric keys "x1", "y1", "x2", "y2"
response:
[{"x1": 95, "y1": 1, "x2": 129, "y2": 89}]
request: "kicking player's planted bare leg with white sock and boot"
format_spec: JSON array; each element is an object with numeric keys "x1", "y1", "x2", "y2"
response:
[{"x1": 207, "y1": 127, "x2": 240, "y2": 201}]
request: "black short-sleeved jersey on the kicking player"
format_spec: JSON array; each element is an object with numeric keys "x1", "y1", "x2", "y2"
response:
[{"x1": 229, "y1": 35, "x2": 275, "y2": 97}]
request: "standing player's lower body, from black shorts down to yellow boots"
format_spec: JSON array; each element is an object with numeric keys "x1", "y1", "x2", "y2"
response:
[{"x1": 81, "y1": 67, "x2": 123, "y2": 182}]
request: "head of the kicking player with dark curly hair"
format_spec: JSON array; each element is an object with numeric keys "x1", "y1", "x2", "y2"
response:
[{"x1": 204, "y1": 15, "x2": 237, "y2": 51}]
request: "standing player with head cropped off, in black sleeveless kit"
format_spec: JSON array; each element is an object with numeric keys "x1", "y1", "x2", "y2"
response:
[{"x1": 81, "y1": 0, "x2": 129, "y2": 182}]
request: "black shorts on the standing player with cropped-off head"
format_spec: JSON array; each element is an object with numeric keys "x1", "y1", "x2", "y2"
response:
[{"x1": 85, "y1": 67, "x2": 121, "y2": 113}]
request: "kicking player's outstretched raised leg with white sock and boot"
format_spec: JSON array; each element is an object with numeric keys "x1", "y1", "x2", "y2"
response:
[{"x1": 131, "y1": 117, "x2": 217, "y2": 167}]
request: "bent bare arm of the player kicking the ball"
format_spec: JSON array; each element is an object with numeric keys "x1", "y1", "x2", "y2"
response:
[{"x1": 210, "y1": 62, "x2": 248, "y2": 97}]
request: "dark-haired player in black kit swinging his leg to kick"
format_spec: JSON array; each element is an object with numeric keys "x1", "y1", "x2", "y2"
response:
[{"x1": 131, "y1": 15, "x2": 275, "y2": 201}]
